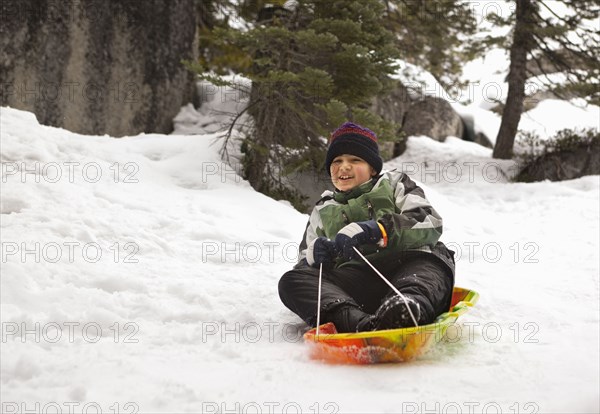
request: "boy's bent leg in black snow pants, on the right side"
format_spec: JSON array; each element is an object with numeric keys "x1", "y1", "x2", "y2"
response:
[{"x1": 383, "y1": 253, "x2": 454, "y2": 325}]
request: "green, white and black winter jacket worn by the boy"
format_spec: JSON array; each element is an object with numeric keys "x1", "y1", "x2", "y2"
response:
[{"x1": 298, "y1": 171, "x2": 454, "y2": 269}]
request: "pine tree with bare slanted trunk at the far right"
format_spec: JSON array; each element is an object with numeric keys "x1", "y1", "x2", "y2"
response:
[{"x1": 490, "y1": 0, "x2": 600, "y2": 159}]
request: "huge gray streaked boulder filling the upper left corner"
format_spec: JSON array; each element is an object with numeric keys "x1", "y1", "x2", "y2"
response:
[{"x1": 0, "y1": 0, "x2": 197, "y2": 136}]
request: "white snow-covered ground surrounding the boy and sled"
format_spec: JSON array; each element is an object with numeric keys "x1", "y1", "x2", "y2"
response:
[{"x1": 0, "y1": 95, "x2": 600, "y2": 413}]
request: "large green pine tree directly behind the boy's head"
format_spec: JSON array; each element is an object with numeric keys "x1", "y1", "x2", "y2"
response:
[{"x1": 198, "y1": 0, "x2": 399, "y2": 207}]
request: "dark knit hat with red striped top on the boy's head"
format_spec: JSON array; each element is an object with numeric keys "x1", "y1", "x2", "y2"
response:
[{"x1": 325, "y1": 122, "x2": 383, "y2": 175}]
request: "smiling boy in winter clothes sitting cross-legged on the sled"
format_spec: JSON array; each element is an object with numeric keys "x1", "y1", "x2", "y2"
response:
[{"x1": 279, "y1": 122, "x2": 454, "y2": 332}]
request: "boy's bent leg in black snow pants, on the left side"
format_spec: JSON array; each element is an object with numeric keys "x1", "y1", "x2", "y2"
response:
[{"x1": 279, "y1": 266, "x2": 386, "y2": 332}]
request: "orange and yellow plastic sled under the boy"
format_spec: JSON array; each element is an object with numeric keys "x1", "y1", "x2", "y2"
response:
[{"x1": 304, "y1": 287, "x2": 479, "y2": 364}]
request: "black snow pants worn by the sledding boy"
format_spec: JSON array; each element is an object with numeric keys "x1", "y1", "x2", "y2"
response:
[{"x1": 279, "y1": 243, "x2": 454, "y2": 331}]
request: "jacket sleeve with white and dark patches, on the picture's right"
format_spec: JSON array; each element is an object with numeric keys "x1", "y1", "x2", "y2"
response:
[{"x1": 379, "y1": 173, "x2": 442, "y2": 250}]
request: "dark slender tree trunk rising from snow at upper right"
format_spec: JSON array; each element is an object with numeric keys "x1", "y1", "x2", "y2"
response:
[{"x1": 493, "y1": 0, "x2": 535, "y2": 159}]
